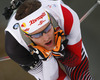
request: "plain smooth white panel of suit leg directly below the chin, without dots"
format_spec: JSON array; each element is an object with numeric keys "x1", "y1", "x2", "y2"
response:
[{"x1": 43, "y1": 56, "x2": 59, "y2": 80}]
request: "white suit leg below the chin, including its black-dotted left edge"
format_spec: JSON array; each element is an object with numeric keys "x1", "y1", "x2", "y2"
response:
[{"x1": 28, "y1": 56, "x2": 58, "y2": 80}]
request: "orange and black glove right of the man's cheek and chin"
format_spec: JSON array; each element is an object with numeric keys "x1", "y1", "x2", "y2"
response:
[{"x1": 52, "y1": 30, "x2": 68, "y2": 58}]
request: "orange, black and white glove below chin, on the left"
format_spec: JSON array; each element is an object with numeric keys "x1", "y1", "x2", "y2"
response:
[{"x1": 29, "y1": 43, "x2": 52, "y2": 60}]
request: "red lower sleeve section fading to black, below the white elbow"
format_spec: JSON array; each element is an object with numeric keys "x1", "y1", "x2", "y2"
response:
[{"x1": 59, "y1": 40, "x2": 82, "y2": 67}]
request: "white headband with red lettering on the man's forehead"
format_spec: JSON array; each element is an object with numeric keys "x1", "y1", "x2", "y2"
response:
[{"x1": 18, "y1": 7, "x2": 50, "y2": 34}]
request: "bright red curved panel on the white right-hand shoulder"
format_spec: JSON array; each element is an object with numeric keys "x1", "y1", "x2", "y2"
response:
[{"x1": 61, "y1": 5, "x2": 73, "y2": 35}]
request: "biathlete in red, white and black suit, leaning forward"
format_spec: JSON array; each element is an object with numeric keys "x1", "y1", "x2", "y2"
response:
[{"x1": 5, "y1": 0, "x2": 93, "y2": 80}]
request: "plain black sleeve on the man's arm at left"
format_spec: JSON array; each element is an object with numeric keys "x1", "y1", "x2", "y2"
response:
[{"x1": 5, "y1": 32, "x2": 34, "y2": 66}]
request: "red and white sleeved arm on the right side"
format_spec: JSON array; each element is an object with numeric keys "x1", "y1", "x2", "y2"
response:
[{"x1": 60, "y1": 4, "x2": 82, "y2": 67}]
